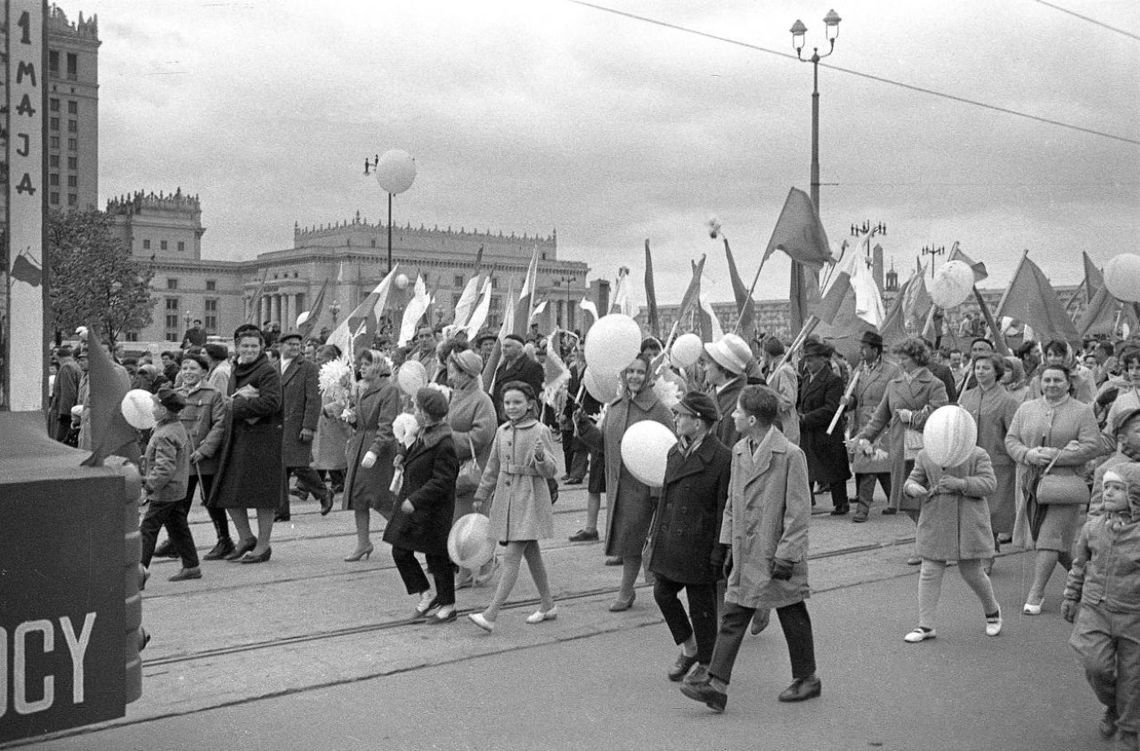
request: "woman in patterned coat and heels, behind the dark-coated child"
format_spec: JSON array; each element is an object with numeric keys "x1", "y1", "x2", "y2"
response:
[{"x1": 341, "y1": 350, "x2": 400, "y2": 563}]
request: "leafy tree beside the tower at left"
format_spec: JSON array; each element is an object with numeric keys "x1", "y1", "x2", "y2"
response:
[{"x1": 47, "y1": 211, "x2": 156, "y2": 342}]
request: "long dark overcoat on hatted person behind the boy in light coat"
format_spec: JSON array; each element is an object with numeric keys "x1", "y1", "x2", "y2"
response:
[{"x1": 796, "y1": 366, "x2": 852, "y2": 484}]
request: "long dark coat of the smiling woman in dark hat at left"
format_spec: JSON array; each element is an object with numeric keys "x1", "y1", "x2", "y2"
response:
[{"x1": 206, "y1": 352, "x2": 285, "y2": 508}]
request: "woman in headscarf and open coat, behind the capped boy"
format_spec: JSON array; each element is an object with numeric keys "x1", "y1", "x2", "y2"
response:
[{"x1": 579, "y1": 354, "x2": 674, "y2": 613}]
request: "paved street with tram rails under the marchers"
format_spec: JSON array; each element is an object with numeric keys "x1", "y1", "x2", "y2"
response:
[{"x1": 6, "y1": 478, "x2": 1109, "y2": 750}]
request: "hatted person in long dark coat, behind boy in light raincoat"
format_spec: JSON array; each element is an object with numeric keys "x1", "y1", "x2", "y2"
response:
[{"x1": 796, "y1": 342, "x2": 852, "y2": 516}]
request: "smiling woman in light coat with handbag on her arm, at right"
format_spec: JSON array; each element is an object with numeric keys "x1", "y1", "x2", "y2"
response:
[{"x1": 1005, "y1": 365, "x2": 1101, "y2": 615}]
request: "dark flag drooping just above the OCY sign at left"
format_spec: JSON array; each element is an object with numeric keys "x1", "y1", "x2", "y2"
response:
[{"x1": 82, "y1": 325, "x2": 139, "y2": 467}]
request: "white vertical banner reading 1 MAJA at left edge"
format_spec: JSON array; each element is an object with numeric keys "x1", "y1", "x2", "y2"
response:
[{"x1": 0, "y1": 0, "x2": 47, "y2": 411}]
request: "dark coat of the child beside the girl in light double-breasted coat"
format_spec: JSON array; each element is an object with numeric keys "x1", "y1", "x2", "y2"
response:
[{"x1": 384, "y1": 423, "x2": 459, "y2": 555}]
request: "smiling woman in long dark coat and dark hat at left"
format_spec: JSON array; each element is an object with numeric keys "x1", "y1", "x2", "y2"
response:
[{"x1": 206, "y1": 325, "x2": 285, "y2": 563}]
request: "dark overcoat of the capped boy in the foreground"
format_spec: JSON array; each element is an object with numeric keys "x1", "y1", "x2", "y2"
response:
[{"x1": 648, "y1": 433, "x2": 732, "y2": 585}]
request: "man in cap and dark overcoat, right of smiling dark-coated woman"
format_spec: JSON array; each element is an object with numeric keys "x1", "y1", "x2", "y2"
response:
[{"x1": 275, "y1": 332, "x2": 333, "y2": 522}]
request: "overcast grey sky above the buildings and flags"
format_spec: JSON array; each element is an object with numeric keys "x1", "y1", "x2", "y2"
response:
[{"x1": 86, "y1": 0, "x2": 1140, "y2": 302}]
